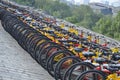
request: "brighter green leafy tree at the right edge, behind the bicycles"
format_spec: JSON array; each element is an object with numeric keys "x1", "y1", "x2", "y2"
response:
[{"x1": 93, "y1": 12, "x2": 120, "y2": 40}]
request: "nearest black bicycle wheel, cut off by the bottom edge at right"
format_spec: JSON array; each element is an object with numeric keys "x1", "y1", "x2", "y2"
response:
[{"x1": 75, "y1": 70, "x2": 106, "y2": 80}]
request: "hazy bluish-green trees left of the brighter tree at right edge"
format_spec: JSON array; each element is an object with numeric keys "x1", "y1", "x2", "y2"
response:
[{"x1": 13, "y1": 0, "x2": 101, "y2": 29}]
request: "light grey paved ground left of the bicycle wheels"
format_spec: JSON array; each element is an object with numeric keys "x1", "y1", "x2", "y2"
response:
[{"x1": 0, "y1": 21, "x2": 54, "y2": 80}]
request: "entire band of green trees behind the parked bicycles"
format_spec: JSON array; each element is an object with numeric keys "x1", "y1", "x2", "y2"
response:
[{"x1": 12, "y1": 0, "x2": 120, "y2": 40}]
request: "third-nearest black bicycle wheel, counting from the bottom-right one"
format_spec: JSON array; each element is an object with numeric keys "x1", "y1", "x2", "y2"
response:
[{"x1": 54, "y1": 56, "x2": 81, "y2": 80}]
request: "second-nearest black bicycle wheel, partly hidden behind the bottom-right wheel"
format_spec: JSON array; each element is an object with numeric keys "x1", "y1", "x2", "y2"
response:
[{"x1": 63, "y1": 62, "x2": 95, "y2": 80}]
